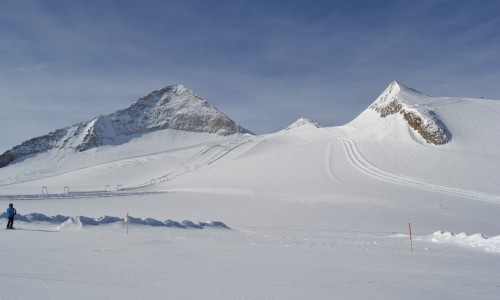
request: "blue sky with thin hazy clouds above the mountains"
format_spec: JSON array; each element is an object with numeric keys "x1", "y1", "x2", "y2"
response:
[{"x1": 0, "y1": 0, "x2": 500, "y2": 152}]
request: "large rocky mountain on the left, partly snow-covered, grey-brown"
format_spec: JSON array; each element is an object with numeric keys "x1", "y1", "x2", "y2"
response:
[{"x1": 0, "y1": 84, "x2": 250, "y2": 168}]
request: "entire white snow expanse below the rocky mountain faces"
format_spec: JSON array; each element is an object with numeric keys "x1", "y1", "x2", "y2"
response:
[{"x1": 0, "y1": 88, "x2": 500, "y2": 300}]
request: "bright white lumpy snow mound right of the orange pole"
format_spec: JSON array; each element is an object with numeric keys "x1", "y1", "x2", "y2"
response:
[{"x1": 428, "y1": 231, "x2": 500, "y2": 253}]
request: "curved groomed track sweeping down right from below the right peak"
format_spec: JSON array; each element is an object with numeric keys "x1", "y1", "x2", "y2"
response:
[{"x1": 339, "y1": 136, "x2": 500, "y2": 204}]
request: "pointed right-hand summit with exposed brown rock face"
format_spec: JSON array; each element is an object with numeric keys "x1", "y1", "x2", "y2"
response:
[{"x1": 370, "y1": 81, "x2": 451, "y2": 145}]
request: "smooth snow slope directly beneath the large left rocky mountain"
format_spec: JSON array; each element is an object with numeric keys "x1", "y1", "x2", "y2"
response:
[{"x1": 0, "y1": 129, "x2": 251, "y2": 193}]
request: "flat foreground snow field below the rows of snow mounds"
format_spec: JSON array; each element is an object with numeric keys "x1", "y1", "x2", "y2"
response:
[{"x1": 0, "y1": 206, "x2": 498, "y2": 299}]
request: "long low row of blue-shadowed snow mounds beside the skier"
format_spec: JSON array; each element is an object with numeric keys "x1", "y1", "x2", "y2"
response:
[{"x1": 0, "y1": 212, "x2": 231, "y2": 229}]
